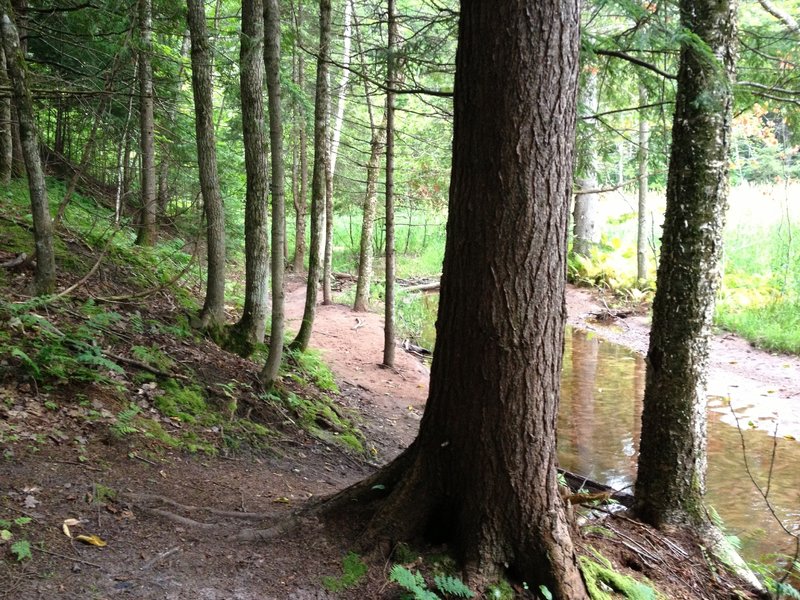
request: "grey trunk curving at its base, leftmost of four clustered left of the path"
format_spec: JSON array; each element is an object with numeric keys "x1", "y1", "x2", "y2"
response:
[{"x1": 187, "y1": 0, "x2": 231, "y2": 334}]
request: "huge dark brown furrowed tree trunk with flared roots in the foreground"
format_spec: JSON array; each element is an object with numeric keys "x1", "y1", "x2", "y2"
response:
[{"x1": 322, "y1": 0, "x2": 587, "y2": 600}]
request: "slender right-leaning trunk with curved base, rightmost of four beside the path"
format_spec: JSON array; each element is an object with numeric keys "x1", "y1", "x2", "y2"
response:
[{"x1": 291, "y1": 0, "x2": 331, "y2": 351}]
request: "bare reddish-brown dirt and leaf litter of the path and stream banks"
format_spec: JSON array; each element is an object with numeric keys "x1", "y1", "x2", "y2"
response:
[{"x1": 0, "y1": 268, "x2": 788, "y2": 600}]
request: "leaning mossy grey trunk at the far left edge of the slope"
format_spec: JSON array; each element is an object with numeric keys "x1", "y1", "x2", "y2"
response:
[{"x1": 0, "y1": 2, "x2": 56, "y2": 296}]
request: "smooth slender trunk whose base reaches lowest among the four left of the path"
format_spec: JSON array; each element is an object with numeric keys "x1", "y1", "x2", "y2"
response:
[{"x1": 261, "y1": 0, "x2": 286, "y2": 386}]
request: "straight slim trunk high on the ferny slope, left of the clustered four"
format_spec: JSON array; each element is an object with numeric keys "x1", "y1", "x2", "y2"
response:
[{"x1": 136, "y1": 0, "x2": 157, "y2": 246}]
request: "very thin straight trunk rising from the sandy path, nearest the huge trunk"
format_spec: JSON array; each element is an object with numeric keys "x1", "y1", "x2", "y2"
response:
[{"x1": 383, "y1": 0, "x2": 397, "y2": 367}]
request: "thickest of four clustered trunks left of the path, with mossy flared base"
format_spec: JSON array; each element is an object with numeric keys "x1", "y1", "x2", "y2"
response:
[{"x1": 231, "y1": 0, "x2": 275, "y2": 355}]
